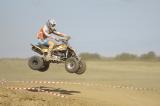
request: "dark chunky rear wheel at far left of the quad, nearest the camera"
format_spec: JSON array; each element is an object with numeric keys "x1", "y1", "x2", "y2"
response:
[{"x1": 28, "y1": 56, "x2": 44, "y2": 70}]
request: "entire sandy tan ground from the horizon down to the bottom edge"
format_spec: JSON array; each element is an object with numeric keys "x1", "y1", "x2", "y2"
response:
[{"x1": 0, "y1": 60, "x2": 160, "y2": 106}]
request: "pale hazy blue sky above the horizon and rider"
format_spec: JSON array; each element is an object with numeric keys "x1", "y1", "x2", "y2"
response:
[{"x1": 0, "y1": 0, "x2": 160, "y2": 58}]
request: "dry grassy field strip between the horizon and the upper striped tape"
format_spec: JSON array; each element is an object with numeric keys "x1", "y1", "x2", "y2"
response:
[{"x1": 0, "y1": 59, "x2": 160, "y2": 87}]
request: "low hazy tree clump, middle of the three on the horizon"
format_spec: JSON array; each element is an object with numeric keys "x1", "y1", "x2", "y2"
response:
[{"x1": 115, "y1": 53, "x2": 138, "y2": 60}]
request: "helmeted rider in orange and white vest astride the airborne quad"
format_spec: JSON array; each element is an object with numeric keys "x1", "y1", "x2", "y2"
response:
[{"x1": 37, "y1": 18, "x2": 69, "y2": 60}]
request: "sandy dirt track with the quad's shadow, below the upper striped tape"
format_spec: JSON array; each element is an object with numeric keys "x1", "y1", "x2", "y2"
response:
[{"x1": 0, "y1": 81, "x2": 160, "y2": 106}]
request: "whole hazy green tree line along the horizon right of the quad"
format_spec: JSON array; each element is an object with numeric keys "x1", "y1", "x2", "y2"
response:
[{"x1": 80, "y1": 51, "x2": 160, "y2": 61}]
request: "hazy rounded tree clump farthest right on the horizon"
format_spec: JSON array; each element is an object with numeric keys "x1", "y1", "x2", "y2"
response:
[{"x1": 140, "y1": 51, "x2": 158, "y2": 60}]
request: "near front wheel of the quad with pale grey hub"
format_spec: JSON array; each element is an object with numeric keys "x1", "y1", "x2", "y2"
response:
[{"x1": 65, "y1": 57, "x2": 79, "y2": 73}]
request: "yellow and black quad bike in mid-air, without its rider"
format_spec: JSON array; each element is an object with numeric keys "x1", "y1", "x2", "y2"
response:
[{"x1": 28, "y1": 37, "x2": 86, "y2": 75}]
